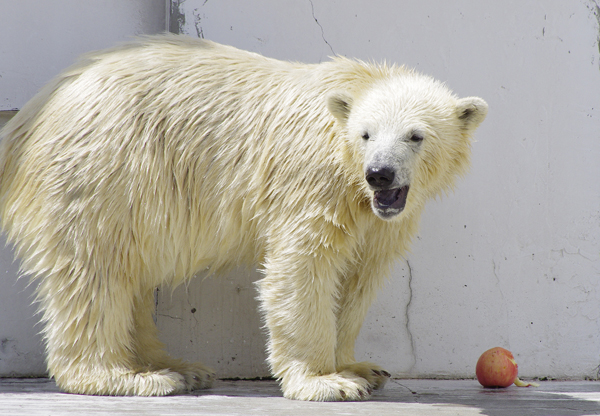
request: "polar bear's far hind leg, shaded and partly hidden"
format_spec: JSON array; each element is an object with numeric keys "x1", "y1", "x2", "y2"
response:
[{"x1": 134, "y1": 291, "x2": 215, "y2": 390}]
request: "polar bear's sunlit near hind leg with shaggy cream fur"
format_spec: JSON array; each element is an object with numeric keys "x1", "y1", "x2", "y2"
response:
[{"x1": 38, "y1": 266, "x2": 186, "y2": 396}]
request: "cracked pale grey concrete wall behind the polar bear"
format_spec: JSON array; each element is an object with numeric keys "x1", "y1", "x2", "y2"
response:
[{"x1": 0, "y1": 0, "x2": 600, "y2": 378}]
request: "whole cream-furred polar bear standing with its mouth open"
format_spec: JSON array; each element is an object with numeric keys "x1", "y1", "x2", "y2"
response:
[{"x1": 0, "y1": 35, "x2": 487, "y2": 401}]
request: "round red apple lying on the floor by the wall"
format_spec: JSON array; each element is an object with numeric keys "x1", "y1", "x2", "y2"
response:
[{"x1": 475, "y1": 347, "x2": 519, "y2": 387}]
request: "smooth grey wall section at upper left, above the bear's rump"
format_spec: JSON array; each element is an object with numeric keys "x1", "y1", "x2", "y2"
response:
[{"x1": 0, "y1": 0, "x2": 167, "y2": 111}]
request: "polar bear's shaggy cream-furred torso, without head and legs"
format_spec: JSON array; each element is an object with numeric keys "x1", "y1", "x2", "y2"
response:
[{"x1": 0, "y1": 35, "x2": 394, "y2": 282}]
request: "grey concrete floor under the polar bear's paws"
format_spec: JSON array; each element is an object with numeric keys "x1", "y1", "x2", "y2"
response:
[{"x1": 0, "y1": 379, "x2": 600, "y2": 416}]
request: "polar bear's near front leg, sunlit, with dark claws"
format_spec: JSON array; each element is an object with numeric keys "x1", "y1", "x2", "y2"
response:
[{"x1": 259, "y1": 250, "x2": 373, "y2": 401}]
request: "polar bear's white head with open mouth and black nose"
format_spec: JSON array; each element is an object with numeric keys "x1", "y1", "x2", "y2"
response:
[{"x1": 327, "y1": 69, "x2": 488, "y2": 220}]
